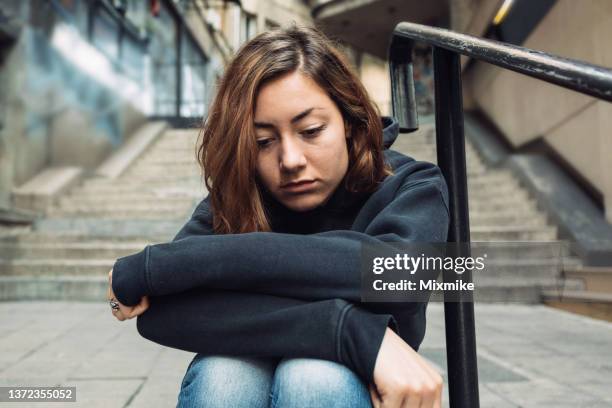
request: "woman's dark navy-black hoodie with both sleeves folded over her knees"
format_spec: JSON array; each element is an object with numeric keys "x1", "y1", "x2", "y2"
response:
[{"x1": 113, "y1": 117, "x2": 449, "y2": 382}]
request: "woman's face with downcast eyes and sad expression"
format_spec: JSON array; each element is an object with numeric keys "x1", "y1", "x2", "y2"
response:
[{"x1": 254, "y1": 71, "x2": 349, "y2": 211}]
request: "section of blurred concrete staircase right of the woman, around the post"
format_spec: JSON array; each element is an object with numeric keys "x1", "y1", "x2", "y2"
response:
[{"x1": 393, "y1": 119, "x2": 583, "y2": 303}]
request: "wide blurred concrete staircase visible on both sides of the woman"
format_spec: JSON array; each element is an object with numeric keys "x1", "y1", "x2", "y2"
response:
[{"x1": 0, "y1": 119, "x2": 580, "y2": 303}]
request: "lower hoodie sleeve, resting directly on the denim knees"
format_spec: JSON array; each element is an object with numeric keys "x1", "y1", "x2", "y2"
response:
[{"x1": 136, "y1": 288, "x2": 400, "y2": 383}]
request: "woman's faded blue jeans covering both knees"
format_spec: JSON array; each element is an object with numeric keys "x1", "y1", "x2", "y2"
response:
[{"x1": 177, "y1": 354, "x2": 372, "y2": 408}]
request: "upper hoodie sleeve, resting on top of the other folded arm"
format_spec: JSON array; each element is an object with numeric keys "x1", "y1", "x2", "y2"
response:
[{"x1": 113, "y1": 162, "x2": 449, "y2": 305}]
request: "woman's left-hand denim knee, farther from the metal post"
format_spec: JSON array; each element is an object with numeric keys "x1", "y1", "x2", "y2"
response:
[{"x1": 177, "y1": 354, "x2": 276, "y2": 408}]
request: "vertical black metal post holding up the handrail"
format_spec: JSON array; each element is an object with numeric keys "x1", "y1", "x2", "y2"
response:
[{"x1": 433, "y1": 47, "x2": 480, "y2": 408}]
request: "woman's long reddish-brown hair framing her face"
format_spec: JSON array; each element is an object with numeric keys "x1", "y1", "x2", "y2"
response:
[{"x1": 197, "y1": 23, "x2": 392, "y2": 234}]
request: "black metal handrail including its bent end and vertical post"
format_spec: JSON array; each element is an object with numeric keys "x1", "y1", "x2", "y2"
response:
[{"x1": 389, "y1": 22, "x2": 612, "y2": 408}]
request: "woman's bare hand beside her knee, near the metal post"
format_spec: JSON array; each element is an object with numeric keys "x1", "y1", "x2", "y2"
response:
[{"x1": 370, "y1": 328, "x2": 443, "y2": 408}]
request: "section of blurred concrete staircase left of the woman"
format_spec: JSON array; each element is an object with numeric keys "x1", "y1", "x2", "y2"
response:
[{"x1": 0, "y1": 130, "x2": 205, "y2": 301}]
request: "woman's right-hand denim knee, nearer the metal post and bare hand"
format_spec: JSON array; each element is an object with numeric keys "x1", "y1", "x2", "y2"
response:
[{"x1": 271, "y1": 358, "x2": 372, "y2": 408}]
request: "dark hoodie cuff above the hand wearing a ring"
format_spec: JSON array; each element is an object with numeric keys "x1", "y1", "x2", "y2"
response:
[{"x1": 112, "y1": 246, "x2": 149, "y2": 306}]
